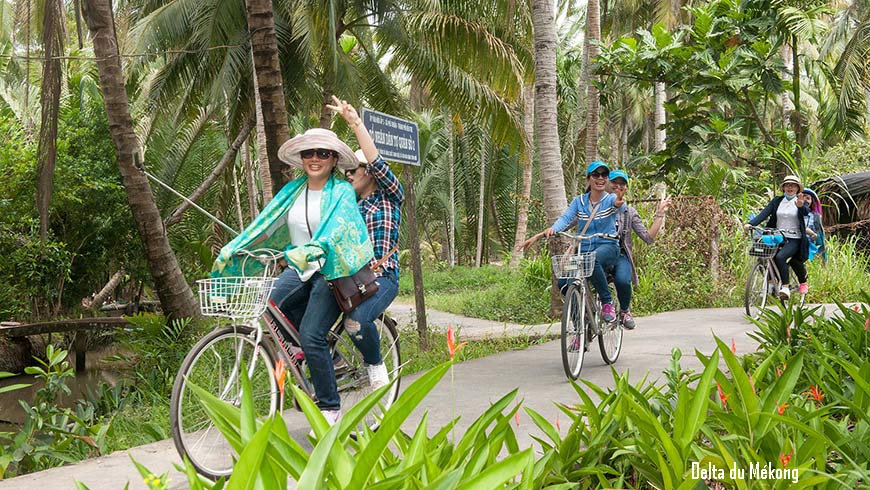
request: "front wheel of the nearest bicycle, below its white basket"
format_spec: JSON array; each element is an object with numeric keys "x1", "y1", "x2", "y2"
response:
[{"x1": 169, "y1": 325, "x2": 280, "y2": 480}]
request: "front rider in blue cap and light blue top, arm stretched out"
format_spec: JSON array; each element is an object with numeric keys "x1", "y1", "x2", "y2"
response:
[{"x1": 523, "y1": 160, "x2": 626, "y2": 322}]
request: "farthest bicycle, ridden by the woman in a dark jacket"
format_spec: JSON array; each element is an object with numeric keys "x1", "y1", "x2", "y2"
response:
[{"x1": 743, "y1": 226, "x2": 806, "y2": 320}]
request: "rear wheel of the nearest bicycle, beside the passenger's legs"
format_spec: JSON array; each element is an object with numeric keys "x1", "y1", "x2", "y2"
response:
[{"x1": 329, "y1": 315, "x2": 402, "y2": 430}]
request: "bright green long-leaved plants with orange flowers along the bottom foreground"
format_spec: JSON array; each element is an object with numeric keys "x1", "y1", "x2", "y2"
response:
[{"x1": 124, "y1": 292, "x2": 870, "y2": 489}]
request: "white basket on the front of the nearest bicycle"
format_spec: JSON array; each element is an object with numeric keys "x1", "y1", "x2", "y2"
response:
[{"x1": 196, "y1": 277, "x2": 275, "y2": 320}]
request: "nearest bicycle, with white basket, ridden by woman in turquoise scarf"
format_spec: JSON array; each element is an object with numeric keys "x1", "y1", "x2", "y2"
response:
[{"x1": 170, "y1": 249, "x2": 402, "y2": 480}]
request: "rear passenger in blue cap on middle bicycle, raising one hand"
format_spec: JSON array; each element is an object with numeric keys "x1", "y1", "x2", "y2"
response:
[{"x1": 610, "y1": 170, "x2": 671, "y2": 330}]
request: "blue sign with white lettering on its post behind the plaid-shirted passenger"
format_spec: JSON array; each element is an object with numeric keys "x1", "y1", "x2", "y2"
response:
[{"x1": 362, "y1": 108, "x2": 429, "y2": 350}]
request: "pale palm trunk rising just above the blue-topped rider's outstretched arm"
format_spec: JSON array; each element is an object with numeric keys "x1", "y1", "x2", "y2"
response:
[{"x1": 532, "y1": 0, "x2": 568, "y2": 223}]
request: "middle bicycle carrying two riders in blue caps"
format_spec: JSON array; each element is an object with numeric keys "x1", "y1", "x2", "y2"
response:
[{"x1": 552, "y1": 232, "x2": 623, "y2": 380}]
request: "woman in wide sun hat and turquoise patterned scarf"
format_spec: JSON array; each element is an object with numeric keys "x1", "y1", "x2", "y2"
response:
[{"x1": 212, "y1": 101, "x2": 374, "y2": 425}]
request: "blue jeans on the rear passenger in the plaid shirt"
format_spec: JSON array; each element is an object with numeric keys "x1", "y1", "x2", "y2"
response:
[{"x1": 344, "y1": 271, "x2": 399, "y2": 364}]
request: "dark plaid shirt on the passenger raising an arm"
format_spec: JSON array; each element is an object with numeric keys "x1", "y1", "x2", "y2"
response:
[{"x1": 359, "y1": 155, "x2": 405, "y2": 278}]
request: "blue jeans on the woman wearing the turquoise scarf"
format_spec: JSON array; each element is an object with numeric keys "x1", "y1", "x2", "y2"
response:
[{"x1": 271, "y1": 267, "x2": 341, "y2": 410}]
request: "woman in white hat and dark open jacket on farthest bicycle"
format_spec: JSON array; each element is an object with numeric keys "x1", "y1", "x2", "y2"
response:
[{"x1": 744, "y1": 175, "x2": 810, "y2": 301}]
